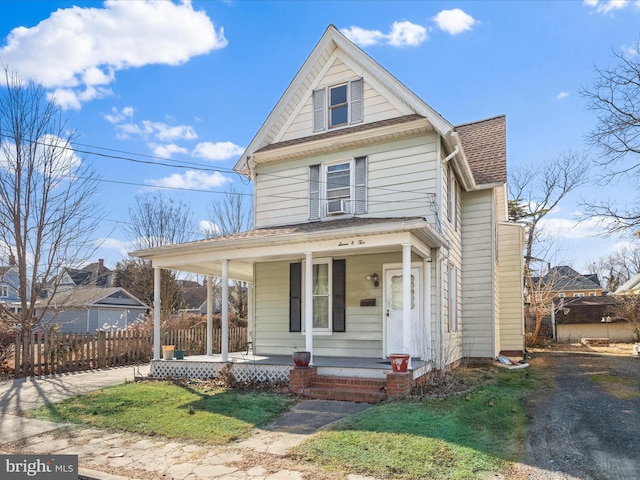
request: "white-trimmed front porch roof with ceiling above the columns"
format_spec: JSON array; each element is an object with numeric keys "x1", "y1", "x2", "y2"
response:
[{"x1": 130, "y1": 218, "x2": 446, "y2": 282}]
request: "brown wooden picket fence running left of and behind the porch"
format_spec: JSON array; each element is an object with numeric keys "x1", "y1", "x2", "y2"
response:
[{"x1": 15, "y1": 327, "x2": 247, "y2": 376}]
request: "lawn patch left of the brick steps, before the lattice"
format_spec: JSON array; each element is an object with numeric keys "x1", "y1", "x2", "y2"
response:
[{"x1": 29, "y1": 382, "x2": 293, "y2": 445}]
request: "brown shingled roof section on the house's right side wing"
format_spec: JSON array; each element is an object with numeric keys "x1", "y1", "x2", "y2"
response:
[{"x1": 455, "y1": 115, "x2": 507, "y2": 186}]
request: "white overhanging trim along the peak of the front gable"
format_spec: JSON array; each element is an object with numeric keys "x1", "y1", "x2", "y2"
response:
[{"x1": 234, "y1": 25, "x2": 453, "y2": 178}]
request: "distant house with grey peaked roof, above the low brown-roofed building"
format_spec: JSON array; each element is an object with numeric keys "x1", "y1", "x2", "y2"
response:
[{"x1": 532, "y1": 265, "x2": 602, "y2": 298}]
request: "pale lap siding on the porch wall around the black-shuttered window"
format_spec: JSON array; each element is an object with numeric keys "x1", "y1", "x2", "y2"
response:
[{"x1": 254, "y1": 252, "x2": 402, "y2": 358}]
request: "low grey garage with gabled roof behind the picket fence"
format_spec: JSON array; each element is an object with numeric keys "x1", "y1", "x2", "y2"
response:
[{"x1": 41, "y1": 287, "x2": 149, "y2": 333}]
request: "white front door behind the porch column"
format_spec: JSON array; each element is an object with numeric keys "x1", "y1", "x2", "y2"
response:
[{"x1": 385, "y1": 267, "x2": 422, "y2": 357}]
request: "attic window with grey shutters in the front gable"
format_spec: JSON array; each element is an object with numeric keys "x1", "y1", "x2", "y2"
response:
[{"x1": 312, "y1": 78, "x2": 364, "y2": 132}]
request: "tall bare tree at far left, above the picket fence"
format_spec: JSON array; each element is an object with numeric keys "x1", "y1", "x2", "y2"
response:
[{"x1": 0, "y1": 69, "x2": 100, "y2": 332}]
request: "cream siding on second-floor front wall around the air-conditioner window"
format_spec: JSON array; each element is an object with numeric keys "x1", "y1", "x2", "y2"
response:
[{"x1": 255, "y1": 134, "x2": 437, "y2": 228}]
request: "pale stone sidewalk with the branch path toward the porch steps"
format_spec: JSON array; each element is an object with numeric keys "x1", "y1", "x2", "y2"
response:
[{"x1": 0, "y1": 366, "x2": 372, "y2": 480}]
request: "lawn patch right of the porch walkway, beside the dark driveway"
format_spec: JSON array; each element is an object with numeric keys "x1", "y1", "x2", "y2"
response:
[{"x1": 294, "y1": 368, "x2": 547, "y2": 480}]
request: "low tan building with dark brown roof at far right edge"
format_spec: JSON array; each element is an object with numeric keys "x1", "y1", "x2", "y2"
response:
[{"x1": 555, "y1": 295, "x2": 635, "y2": 343}]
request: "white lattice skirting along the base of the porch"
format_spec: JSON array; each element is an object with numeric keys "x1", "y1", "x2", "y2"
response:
[{"x1": 149, "y1": 360, "x2": 291, "y2": 382}]
